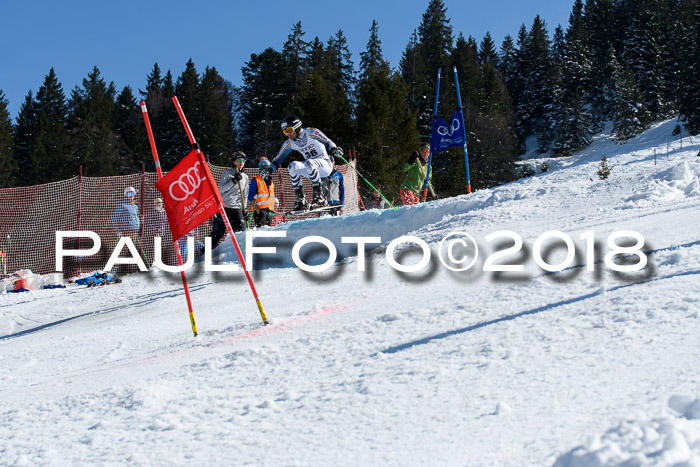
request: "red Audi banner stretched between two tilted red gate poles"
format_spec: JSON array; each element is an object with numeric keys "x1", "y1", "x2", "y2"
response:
[{"x1": 156, "y1": 149, "x2": 219, "y2": 239}]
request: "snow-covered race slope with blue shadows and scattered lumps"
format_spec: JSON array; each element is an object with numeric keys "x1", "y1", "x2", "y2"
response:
[{"x1": 0, "y1": 122, "x2": 700, "y2": 466}]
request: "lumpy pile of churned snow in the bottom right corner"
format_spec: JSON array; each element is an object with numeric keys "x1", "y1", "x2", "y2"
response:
[{"x1": 554, "y1": 396, "x2": 700, "y2": 467}]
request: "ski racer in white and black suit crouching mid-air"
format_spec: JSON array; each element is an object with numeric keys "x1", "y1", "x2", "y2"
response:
[{"x1": 272, "y1": 115, "x2": 343, "y2": 211}]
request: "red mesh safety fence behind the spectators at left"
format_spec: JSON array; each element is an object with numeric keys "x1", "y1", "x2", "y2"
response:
[{"x1": 0, "y1": 160, "x2": 360, "y2": 278}]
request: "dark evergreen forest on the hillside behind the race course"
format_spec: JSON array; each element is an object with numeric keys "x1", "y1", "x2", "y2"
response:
[{"x1": 0, "y1": 0, "x2": 700, "y2": 197}]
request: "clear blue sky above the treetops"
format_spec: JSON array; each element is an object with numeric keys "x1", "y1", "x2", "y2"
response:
[{"x1": 0, "y1": 0, "x2": 573, "y2": 119}]
